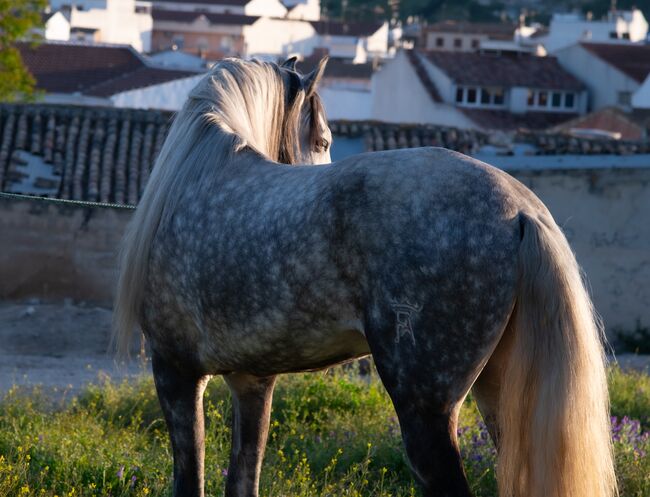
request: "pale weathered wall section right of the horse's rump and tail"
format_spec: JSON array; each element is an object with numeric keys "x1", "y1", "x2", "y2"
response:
[{"x1": 509, "y1": 168, "x2": 650, "y2": 334}]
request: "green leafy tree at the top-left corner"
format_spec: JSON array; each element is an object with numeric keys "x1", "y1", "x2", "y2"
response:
[{"x1": 0, "y1": 0, "x2": 47, "y2": 101}]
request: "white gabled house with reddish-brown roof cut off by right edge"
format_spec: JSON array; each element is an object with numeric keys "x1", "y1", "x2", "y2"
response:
[{"x1": 555, "y1": 42, "x2": 650, "y2": 110}]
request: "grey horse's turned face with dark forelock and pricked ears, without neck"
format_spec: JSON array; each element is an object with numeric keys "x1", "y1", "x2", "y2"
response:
[{"x1": 280, "y1": 57, "x2": 332, "y2": 164}]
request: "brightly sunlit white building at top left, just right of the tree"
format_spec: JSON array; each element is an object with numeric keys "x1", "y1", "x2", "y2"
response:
[{"x1": 50, "y1": 0, "x2": 153, "y2": 52}]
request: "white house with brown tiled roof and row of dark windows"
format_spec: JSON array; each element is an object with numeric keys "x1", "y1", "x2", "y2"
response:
[{"x1": 372, "y1": 51, "x2": 587, "y2": 130}]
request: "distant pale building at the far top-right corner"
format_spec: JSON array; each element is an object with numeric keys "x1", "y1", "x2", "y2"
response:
[{"x1": 539, "y1": 9, "x2": 648, "y2": 53}]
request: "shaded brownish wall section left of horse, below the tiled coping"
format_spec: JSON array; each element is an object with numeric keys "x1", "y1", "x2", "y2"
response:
[{"x1": 0, "y1": 198, "x2": 133, "y2": 304}]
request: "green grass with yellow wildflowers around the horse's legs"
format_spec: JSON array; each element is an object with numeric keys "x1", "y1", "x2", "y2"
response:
[{"x1": 0, "y1": 360, "x2": 650, "y2": 497}]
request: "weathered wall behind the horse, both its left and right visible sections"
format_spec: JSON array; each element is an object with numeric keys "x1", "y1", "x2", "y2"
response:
[{"x1": 0, "y1": 163, "x2": 650, "y2": 338}]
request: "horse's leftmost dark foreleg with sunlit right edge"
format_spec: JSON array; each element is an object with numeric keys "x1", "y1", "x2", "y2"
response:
[{"x1": 151, "y1": 353, "x2": 210, "y2": 497}]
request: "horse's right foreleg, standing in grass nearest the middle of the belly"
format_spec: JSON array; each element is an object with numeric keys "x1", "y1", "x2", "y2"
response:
[{"x1": 224, "y1": 373, "x2": 276, "y2": 497}]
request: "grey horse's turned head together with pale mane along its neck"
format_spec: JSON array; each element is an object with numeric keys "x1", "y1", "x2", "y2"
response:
[{"x1": 185, "y1": 58, "x2": 332, "y2": 164}]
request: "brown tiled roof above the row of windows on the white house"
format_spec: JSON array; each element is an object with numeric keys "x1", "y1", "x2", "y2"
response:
[{"x1": 422, "y1": 51, "x2": 584, "y2": 90}]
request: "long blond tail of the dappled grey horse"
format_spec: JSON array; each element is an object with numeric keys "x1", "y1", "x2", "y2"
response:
[{"x1": 497, "y1": 213, "x2": 617, "y2": 497}]
